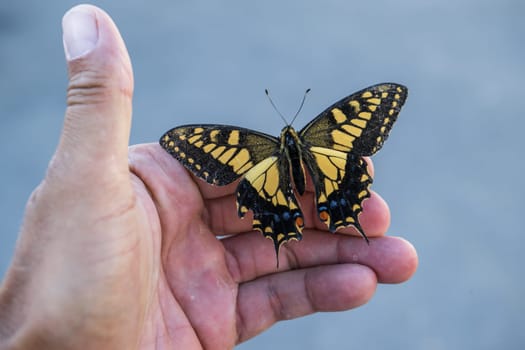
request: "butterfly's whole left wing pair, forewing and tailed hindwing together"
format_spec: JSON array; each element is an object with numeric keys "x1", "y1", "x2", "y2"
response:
[{"x1": 160, "y1": 121, "x2": 303, "y2": 262}]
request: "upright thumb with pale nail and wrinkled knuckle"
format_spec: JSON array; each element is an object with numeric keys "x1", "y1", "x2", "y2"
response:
[{"x1": 54, "y1": 5, "x2": 133, "y2": 176}]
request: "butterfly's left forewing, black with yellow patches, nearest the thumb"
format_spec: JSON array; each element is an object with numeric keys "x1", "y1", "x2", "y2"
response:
[{"x1": 160, "y1": 125, "x2": 279, "y2": 186}]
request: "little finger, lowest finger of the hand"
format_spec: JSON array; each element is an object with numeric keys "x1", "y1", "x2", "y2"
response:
[{"x1": 237, "y1": 264, "x2": 377, "y2": 342}]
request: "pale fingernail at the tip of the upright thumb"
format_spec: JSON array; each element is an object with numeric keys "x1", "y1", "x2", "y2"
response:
[{"x1": 62, "y1": 6, "x2": 98, "y2": 61}]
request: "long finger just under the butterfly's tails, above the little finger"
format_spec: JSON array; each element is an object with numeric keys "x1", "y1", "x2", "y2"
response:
[{"x1": 223, "y1": 230, "x2": 418, "y2": 283}]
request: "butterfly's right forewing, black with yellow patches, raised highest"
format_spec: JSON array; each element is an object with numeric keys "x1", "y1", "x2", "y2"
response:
[{"x1": 299, "y1": 83, "x2": 407, "y2": 156}]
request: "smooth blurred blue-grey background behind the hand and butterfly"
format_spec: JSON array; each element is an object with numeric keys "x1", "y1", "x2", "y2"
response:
[{"x1": 0, "y1": 0, "x2": 525, "y2": 349}]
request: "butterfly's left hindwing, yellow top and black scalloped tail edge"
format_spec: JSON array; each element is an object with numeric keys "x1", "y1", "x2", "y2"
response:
[{"x1": 237, "y1": 156, "x2": 304, "y2": 262}]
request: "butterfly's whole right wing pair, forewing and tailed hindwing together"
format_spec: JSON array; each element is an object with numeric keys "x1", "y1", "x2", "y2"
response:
[{"x1": 299, "y1": 83, "x2": 407, "y2": 241}]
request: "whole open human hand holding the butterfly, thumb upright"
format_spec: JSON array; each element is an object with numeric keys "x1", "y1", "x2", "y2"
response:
[{"x1": 0, "y1": 5, "x2": 417, "y2": 349}]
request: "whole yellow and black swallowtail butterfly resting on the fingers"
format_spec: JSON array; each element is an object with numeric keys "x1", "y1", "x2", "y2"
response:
[{"x1": 160, "y1": 83, "x2": 407, "y2": 262}]
